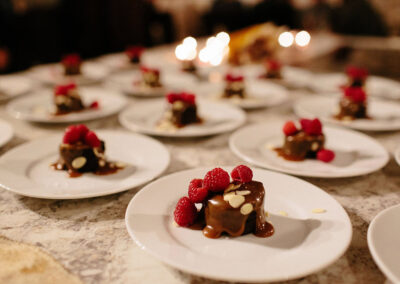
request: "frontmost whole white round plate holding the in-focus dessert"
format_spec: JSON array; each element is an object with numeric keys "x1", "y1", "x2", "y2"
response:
[{"x1": 125, "y1": 167, "x2": 352, "y2": 283}]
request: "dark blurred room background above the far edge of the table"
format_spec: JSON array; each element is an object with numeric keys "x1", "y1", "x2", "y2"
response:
[{"x1": 0, "y1": 0, "x2": 400, "y2": 78}]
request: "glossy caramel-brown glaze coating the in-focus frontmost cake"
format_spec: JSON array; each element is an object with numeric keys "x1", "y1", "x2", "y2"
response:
[{"x1": 199, "y1": 181, "x2": 274, "y2": 239}]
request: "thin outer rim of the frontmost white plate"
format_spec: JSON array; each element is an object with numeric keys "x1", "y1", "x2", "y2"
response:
[{"x1": 125, "y1": 165, "x2": 353, "y2": 283}]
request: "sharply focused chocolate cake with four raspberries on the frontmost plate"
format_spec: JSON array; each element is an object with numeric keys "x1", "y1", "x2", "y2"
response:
[{"x1": 174, "y1": 165, "x2": 274, "y2": 239}]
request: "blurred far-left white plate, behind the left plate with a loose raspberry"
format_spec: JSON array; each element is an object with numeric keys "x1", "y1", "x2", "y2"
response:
[{"x1": 29, "y1": 62, "x2": 110, "y2": 85}]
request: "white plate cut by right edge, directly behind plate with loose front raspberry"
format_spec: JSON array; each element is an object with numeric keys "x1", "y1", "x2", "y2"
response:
[{"x1": 294, "y1": 94, "x2": 400, "y2": 131}]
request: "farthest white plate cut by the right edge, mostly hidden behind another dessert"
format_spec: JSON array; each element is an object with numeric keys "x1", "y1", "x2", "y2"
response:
[{"x1": 309, "y1": 73, "x2": 400, "y2": 100}]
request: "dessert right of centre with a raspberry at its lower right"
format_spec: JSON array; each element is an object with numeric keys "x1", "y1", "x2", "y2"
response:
[{"x1": 274, "y1": 118, "x2": 335, "y2": 163}]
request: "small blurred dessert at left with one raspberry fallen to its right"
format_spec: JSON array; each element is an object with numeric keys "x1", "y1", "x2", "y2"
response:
[{"x1": 53, "y1": 83, "x2": 99, "y2": 115}]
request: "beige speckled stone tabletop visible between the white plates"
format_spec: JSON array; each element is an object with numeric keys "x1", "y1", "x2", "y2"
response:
[{"x1": 0, "y1": 72, "x2": 400, "y2": 284}]
